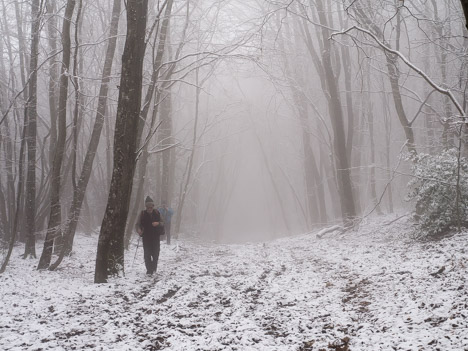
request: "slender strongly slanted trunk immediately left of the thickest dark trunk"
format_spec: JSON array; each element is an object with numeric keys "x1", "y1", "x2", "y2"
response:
[{"x1": 49, "y1": 0, "x2": 121, "y2": 270}]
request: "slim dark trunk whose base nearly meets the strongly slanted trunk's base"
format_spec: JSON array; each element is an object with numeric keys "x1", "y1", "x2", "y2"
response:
[{"x1": 37, "y1": 0, "x2": 75, "y2": 269}]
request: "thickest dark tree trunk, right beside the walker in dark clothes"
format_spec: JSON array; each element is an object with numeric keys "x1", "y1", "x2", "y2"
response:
[{"x1": 94, "y1": 0, "x2": 148, "y2": 283}]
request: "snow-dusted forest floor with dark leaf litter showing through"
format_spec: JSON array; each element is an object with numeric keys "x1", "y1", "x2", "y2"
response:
[{"x1": 0, "y1": 217, "x2": 468, "y2": 351}]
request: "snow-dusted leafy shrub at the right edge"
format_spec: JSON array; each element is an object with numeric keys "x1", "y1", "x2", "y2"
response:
[{"x1": 407, "y1": 149, "x2": 468, "y2": 235}]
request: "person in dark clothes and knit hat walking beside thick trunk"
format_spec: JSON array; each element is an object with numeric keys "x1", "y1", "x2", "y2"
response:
[{"x1": 136, "y1": 196, "x2": 164, "y2": 275}]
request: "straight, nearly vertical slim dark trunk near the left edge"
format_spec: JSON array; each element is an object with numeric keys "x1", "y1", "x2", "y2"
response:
[{"x1": 24, "y1": 0, "x2": 41, "y2": 258}]
